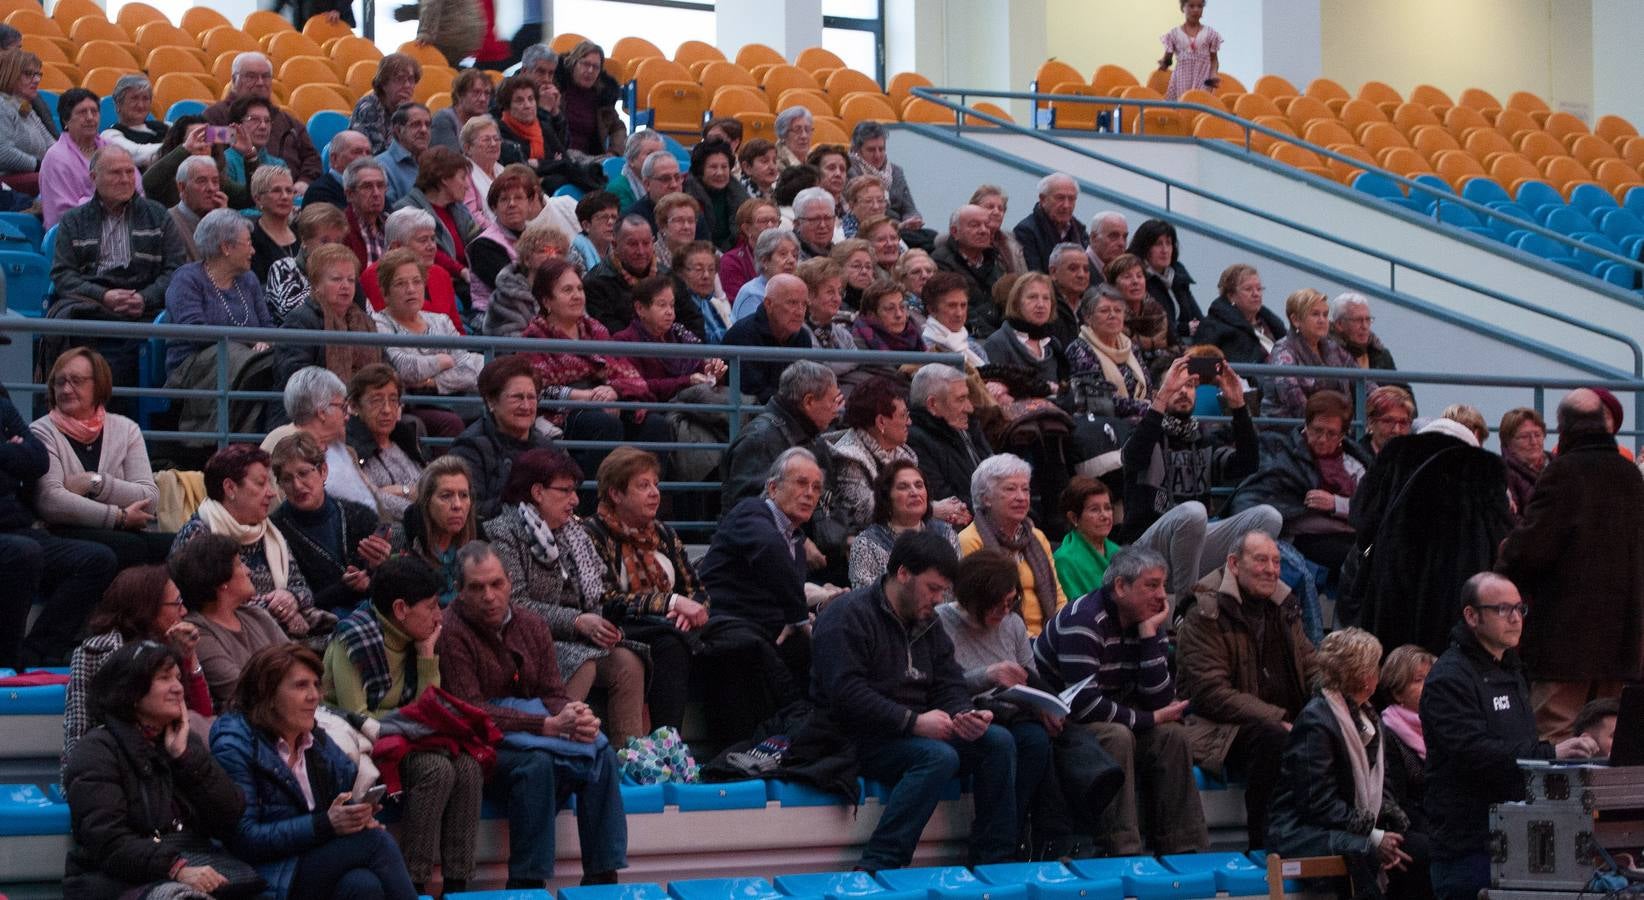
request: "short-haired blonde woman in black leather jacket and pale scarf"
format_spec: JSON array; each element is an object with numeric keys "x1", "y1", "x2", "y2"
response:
[{"x1": 1268, "y1": 629, "x2": 1432, "y2": 898}]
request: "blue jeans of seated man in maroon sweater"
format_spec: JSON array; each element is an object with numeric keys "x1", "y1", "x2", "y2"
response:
[{"x1": 485, "y1": 745, "x2": 628, "y2": 882}]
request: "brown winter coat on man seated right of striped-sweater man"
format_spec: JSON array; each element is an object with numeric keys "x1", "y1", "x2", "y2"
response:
[{"x1": 1175, "y1": 566, "x2": 1315, "y2": 770}]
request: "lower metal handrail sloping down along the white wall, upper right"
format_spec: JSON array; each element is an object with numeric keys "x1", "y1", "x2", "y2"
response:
[{"x1": 904, "y1": 96, "x2": 1644, "y2": 375}]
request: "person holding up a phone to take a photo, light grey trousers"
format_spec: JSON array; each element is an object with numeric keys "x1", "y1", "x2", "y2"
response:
[{"x1": 1113, "y1": 347, "x2": 1284, "y2": 597}]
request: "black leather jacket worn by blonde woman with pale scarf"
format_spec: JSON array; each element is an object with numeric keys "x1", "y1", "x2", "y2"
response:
[{"x1": 1268, "y1": 694, "x2": 1411, "y2": 898}]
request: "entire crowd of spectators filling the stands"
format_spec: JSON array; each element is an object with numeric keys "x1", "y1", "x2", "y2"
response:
[{"x1": 0, "y1": 31, "x2": 1644, "y2": 897}]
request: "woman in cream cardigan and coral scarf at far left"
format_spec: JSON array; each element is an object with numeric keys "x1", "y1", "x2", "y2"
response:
[{"x1": 30, "y1": 347, "x2": 171, "y2": 568}]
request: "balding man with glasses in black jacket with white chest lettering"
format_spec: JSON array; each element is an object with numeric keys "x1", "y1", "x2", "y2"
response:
[{"x1": 1422, "y1": 573, "x2": 1598, "y2": 900}]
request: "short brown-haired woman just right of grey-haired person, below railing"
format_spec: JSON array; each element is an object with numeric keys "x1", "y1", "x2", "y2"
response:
[{"x1": 345, "y1": 364, "x2": 427, "y2": 522}]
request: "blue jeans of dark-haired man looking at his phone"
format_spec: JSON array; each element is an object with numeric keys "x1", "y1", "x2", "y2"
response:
[{"x1": 857, "y1": 726, "x2": 1016, "y2": 870}]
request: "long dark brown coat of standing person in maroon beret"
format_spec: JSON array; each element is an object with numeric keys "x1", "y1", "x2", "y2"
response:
[{"x1": 1496, "y1": 431, "x2": 1644, "y2": 681}]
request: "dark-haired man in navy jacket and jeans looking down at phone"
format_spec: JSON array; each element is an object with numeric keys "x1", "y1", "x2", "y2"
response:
[{"x1": 812, "y1": 530, "x2": 1016, "y2": 872}]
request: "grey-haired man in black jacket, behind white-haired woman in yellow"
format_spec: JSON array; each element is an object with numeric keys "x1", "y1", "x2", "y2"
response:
[{"x1": 907, "y1": 362, "x2": 993, "y2": 516}]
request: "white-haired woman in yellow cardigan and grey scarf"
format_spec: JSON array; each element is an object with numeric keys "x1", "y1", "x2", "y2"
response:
[{"x1": 958, "y1": 452, "x2": 1067, "y2": 637}]
